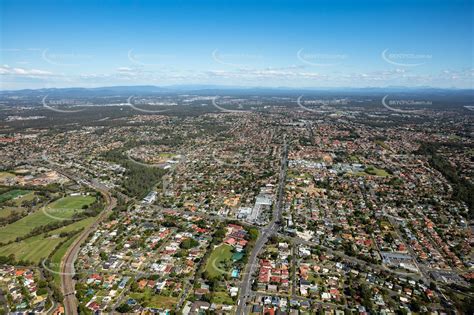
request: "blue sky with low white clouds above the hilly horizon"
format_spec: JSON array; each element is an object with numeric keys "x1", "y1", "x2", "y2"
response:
[{"x1": 0, "y1": 0, "x2": 474, "y2": 90}]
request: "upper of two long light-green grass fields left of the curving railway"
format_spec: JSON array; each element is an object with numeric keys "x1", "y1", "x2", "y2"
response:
[{"x1": 0, "y1": 196, "x2": 95, "y2": 241}]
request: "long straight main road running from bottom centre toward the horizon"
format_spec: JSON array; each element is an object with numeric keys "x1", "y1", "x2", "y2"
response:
[{"x1": 236, "y1": 138, "x2": 288, "y2": 315}]
